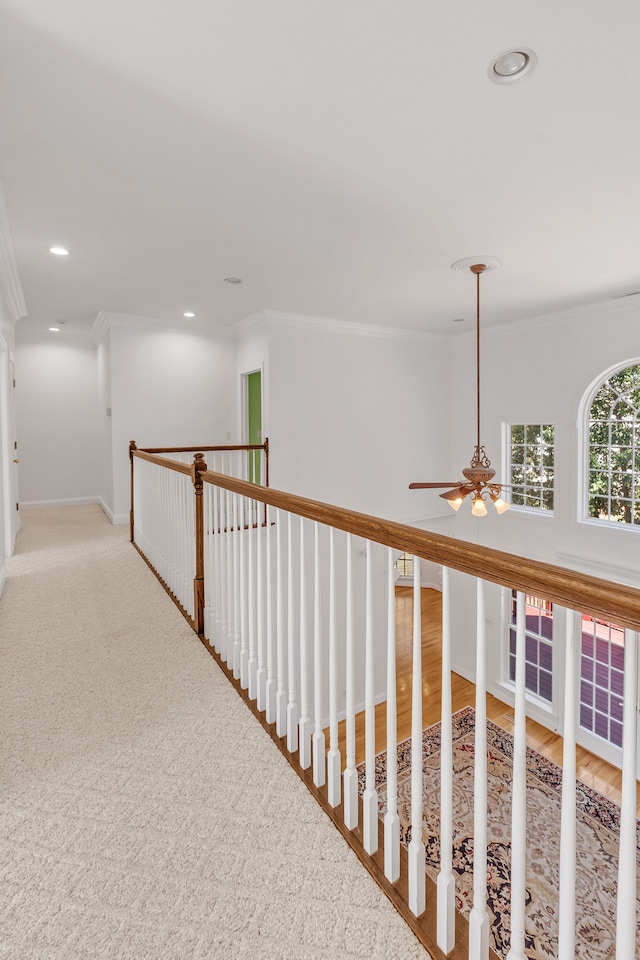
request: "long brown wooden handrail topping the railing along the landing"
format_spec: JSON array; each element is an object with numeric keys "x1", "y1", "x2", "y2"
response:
[{"x1": 132, "y1": 450, "x2": 640, "y2": 631}]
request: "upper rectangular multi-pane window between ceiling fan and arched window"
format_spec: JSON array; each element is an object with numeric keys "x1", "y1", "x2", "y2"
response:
[{"x1": 508, "y1": 423, "x2": 554, "y2": 512}]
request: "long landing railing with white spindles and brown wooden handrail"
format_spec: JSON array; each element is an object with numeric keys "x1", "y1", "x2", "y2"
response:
[{"x1": 132, "y1": 452, "x2": 640, "y2": 960}]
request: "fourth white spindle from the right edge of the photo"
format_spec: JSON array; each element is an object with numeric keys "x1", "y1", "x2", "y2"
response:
[{"x1": 469, "y1": 578, "x2": 489, "y2": 960}]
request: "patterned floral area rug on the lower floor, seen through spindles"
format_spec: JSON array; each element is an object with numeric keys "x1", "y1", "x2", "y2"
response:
[{"x1": 358, "y1": 707, "x2": 640, "y2": 960}]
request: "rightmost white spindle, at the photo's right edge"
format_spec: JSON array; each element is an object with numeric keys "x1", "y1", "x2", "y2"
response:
[{"x1": 616, "y1": 630, "x2": 638, "y2": 960}]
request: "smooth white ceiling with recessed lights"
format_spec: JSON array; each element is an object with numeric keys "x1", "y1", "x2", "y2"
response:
[{"x1": 0, "y1": 0, "x2": 640, "y2": 334}]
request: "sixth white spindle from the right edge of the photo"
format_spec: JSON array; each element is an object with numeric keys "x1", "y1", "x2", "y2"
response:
[{"x1": 409, "y1": 557, "x2": 426, "y2": 917}]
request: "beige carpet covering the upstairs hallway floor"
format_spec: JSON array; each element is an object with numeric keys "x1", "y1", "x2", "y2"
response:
[{"x1": 0, "y1": 507, "x2": 427, "y2": 960}]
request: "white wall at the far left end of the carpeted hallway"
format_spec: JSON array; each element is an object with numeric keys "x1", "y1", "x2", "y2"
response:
[{"x1": 16, "y1": 339, "x2": 100, "y2": 506}]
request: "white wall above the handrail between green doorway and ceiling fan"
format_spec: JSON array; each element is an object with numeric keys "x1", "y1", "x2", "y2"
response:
[{"x1": 268, "y1": 320, "x2": 449, "y2": 522}]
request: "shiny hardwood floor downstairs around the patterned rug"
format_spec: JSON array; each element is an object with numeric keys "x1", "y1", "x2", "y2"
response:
[{"x1": 339, "y1": 587, "x2": 640, "y2": 816}]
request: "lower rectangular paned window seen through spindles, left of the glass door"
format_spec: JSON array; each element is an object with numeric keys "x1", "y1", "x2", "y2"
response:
[{"x1": 509, "y1": 590, "x2": 553, "y2": 703}]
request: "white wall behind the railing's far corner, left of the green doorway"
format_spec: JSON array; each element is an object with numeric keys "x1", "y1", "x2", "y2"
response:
[{"x1": 103, "y1": 325, "x2": 237, "y2": 522}]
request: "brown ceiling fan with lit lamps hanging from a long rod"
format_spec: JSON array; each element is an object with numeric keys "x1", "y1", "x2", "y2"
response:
[{"x1": 409, "y1": 260, "x2": 509, "y2": 517}]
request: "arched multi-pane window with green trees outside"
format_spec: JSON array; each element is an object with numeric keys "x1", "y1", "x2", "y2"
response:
[{"x1": 587, "y1": 364, "x2": 640, "y2": 525}]
